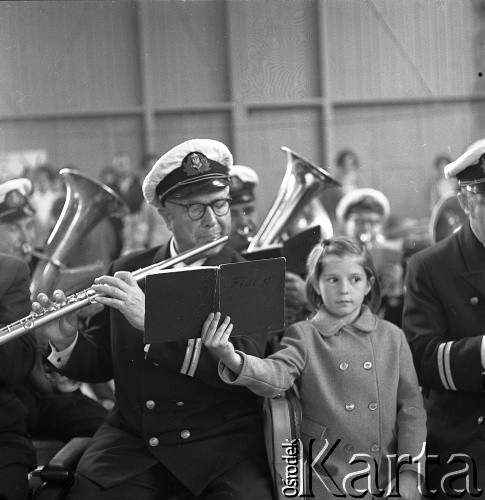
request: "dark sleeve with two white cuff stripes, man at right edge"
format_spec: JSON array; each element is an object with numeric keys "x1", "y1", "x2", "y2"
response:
[{"x1": 403, "y1": 228, "x2": 485, "y2": 393}]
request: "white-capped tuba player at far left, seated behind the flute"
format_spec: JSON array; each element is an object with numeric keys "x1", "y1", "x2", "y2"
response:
[{"x1": 0, "y1": 179, "x2": 107, "y2": 442}]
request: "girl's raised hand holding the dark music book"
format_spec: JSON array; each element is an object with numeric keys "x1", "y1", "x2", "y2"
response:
[{"x1": 201, "y1": 312, "x2": 242, "y2": 374}]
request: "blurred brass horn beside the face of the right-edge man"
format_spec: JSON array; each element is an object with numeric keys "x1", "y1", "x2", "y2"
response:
[{"x1": 429, "y1": 193, "x2": 467, "y2": 244}]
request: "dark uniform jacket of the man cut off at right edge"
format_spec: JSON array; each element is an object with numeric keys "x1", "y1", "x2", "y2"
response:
[{"x1": 403, "y1": 222, "x2": 485, "y2": 459}]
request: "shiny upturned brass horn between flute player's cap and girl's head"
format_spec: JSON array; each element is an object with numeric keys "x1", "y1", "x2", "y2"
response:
[{"x1": 247, "y1": 146, "x2": 340, "y2": 253}]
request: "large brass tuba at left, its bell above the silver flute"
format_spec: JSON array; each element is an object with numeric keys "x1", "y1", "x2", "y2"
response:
[{"x1": 29, "y1": 168, "x2": 129, "y2": 393}]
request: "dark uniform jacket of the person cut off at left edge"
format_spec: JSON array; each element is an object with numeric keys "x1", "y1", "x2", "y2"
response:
[{"x1": 0, "y1": 254, "x2": 36, "y2": 468}]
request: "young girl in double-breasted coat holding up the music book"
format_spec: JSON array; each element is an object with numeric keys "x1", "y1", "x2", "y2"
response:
[{"x1": 202, "y1": 237, "x2": 426, "y2": 499}]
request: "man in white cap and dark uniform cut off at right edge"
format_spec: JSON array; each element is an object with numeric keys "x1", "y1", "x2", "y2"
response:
[{"x1": 403, "y1": 139, "x2": 485, "y2": 498}]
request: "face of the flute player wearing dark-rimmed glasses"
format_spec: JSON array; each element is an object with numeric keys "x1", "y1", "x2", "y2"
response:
[{"x1": 159, "y1": 186, "x2": 231, "y2": 256}]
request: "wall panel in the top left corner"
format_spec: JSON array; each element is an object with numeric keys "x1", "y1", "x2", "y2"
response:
[{"x1": 0, "y1": 1, "x2": 140, "y2": 115}]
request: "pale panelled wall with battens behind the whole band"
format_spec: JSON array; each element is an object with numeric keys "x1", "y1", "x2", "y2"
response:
[{"x1": 0, "y1": 0, "x2": 485, "y2": 223}]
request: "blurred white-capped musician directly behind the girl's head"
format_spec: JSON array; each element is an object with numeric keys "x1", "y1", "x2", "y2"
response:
[{"x1": 336, "y1": 188, "x2": 404, "y2": 327}]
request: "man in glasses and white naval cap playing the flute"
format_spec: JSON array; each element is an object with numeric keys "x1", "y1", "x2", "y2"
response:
[{"x1": 38, "y1": 139, "x2": 272, "y2": 500}]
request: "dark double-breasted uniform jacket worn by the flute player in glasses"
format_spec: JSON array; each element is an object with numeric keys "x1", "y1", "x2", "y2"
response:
[{"x1": 58, "y1": 245, "x2": 266, "y2": 494}]
